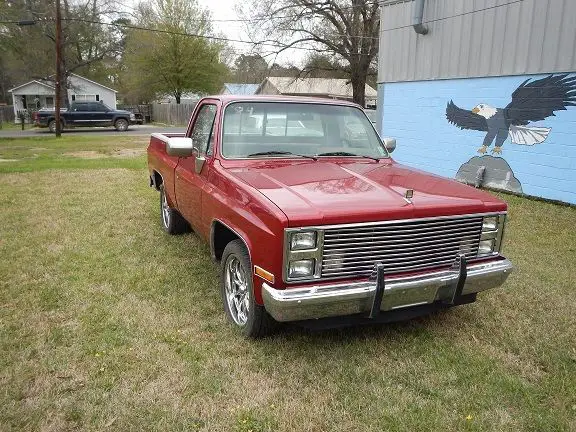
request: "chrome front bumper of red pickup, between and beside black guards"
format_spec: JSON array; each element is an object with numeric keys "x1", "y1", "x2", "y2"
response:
[{"x1": 262, "y1": 259, "x2": 513, "y2": 321}]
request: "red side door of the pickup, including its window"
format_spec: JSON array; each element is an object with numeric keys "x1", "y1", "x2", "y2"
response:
[{"x1": 175, "y1": 100, "x2": 217, "y2": 232}]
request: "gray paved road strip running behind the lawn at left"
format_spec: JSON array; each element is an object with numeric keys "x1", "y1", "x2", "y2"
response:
[{"x1": 0, "y1": 125, "x2": 186, "y2": 138}]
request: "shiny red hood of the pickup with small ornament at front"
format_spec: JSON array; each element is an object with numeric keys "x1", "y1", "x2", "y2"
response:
[{"x1": 229, "y1": 159, "x2": 506, "y2": 226}]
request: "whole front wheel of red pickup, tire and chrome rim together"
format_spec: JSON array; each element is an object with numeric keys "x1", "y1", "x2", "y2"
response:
[{"x1": 220, "y1": 240, "x2": 274, "y2": 338}]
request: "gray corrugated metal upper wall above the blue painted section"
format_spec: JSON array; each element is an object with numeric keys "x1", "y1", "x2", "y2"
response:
[{"x1": 378, "y1": 0, "x2": 576, "y2": 82}]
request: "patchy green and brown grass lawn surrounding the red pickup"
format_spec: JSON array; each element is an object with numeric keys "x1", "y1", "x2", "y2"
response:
[{"x1": 0, "y1": 136, "x2": 576, "y2": 432}]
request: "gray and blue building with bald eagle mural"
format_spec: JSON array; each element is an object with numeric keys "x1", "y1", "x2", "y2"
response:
[{"x1": 378, "y1": 0, "x2": 576, "y2": 204}]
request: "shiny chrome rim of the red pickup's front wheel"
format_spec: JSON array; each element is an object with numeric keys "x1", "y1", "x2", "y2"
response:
[{"x1": 224, "y1": 255, "x2": 250, "y2": 326}]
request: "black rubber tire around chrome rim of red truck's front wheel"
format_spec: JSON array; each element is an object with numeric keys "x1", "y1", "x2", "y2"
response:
[{"x1": 220, "y1": 240, "x2": 275, "y2": 339}]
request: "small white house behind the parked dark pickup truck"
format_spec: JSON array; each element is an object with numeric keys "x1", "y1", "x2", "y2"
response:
[{"x1": 8, "y1": 74, "x2": 117, "y2": 123}]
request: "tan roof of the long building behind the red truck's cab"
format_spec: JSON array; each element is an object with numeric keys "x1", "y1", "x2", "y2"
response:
[{"x1": 259, "y1": 77, "x2": 377, "y2": 98}]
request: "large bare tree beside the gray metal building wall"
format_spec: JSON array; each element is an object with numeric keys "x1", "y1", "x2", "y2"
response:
[{"x1": 240, "y1": 0, "x2": 380, "y2": 105}]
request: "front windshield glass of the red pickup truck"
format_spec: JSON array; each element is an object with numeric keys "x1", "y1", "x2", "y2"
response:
[{"x1": 222, "y1": 102, "x2": 388, "y2": 158}]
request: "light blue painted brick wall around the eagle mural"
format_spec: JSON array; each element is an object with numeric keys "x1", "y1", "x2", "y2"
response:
[{"x1": 379, "y1": 75, "x2": 576, "y2": 204}]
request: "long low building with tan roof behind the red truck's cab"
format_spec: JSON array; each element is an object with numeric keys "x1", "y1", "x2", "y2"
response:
[{"x1": 256, "y1": 77, "x2": 377, "y2": 106}]
